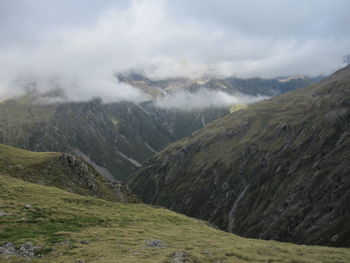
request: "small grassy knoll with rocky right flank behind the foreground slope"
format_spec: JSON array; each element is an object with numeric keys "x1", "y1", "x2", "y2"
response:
[{"x1": 0, "y1": 144, "x2": 138, "y2": 203}]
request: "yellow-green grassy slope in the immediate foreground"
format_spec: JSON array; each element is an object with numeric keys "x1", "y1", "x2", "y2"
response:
[{"x1": 0, "y1": 175, "x2": 350, "y2": 263}]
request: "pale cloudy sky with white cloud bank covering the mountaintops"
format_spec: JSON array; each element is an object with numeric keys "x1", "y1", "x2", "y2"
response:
[{"x1": 0, "y1": 0, "x2": 350, "y2": 101}]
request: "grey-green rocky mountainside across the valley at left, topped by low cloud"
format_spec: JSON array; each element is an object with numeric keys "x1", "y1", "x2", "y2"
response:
[{"x1": 0, "y1": 97, "x2": 172, "y2": 182}]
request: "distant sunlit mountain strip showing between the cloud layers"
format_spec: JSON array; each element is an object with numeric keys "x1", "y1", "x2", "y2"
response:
[{"x1": 117, "y1": 73, "x2": 323, "y2": 97}]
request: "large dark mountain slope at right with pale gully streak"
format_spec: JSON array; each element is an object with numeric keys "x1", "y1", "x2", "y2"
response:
[{"x1": 129, "y1": 66, "x2": 350, "y2": 247}]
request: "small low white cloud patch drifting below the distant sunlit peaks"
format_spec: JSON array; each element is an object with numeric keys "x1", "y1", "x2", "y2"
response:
[{"x1": 155, "y1": 88, "x2": 268, "y2": 111}]
